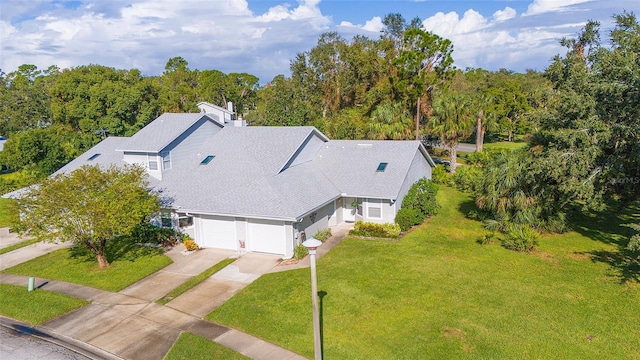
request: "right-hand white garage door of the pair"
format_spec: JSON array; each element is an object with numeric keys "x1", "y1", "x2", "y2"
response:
[{"x1": 248, "y1": 220, "x2": 287, "y2": 255}]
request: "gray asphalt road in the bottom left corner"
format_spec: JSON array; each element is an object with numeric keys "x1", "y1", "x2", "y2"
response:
[{"x1": 0, "y1": 326, "x2": 90, "y2": 360}]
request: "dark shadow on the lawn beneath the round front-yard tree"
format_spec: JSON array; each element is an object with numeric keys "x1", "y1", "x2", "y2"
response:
[{"x1": 69, "y1": 236, "x2": 164, "y2": 263}]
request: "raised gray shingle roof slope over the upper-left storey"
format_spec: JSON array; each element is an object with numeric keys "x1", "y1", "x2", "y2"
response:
[{"x1": 116, "y1": 113, "x2": 217, "y2": 152}]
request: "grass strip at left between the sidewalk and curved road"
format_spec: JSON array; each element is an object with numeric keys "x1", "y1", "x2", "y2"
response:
[{"x1": 0, "y1": 284, "x2": 89, "y2": 325}]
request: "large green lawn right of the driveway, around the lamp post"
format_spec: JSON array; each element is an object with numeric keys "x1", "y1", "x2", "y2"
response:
[{"x1": 206, "y1": 187, "x2": 640, "y2": 359}]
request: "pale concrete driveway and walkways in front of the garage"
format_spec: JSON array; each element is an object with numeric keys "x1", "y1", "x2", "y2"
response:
[{"x1": 0, "y1": 224, "x2": 352, "y2": 360}]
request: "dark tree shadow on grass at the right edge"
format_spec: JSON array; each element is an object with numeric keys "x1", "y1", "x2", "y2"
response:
[{"x1": 571, "y1": 201, "x2": 640, "y2": 284}]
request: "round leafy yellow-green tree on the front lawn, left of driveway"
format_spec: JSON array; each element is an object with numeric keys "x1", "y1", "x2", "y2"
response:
[{"x1": 19, "y1": 166, "x2": 160, "y2": 268}]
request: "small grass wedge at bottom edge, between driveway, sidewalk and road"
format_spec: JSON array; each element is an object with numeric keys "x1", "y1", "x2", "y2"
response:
[{"x1": 164, "y1": 332, "x2": 250, "y2": 360}]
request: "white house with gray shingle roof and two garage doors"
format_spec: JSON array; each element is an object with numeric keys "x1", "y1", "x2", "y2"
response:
[{"x1": 45, "y1": 108, "x2": 435, "y2": 257}]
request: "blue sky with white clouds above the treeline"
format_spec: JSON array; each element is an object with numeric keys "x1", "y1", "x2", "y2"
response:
[{"x1": 0, "y1": 0, "x2": 640, "y2": 84}]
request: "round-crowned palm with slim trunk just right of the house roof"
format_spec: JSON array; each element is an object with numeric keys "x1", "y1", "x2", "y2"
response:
[{"x1": 429, "y1": 93, "x2": 475, "y2": 173}]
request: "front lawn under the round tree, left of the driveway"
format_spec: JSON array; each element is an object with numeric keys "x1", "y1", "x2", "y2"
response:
[{"x1": 2, "y1": 239, "x2": 172, "y2": 291}]
